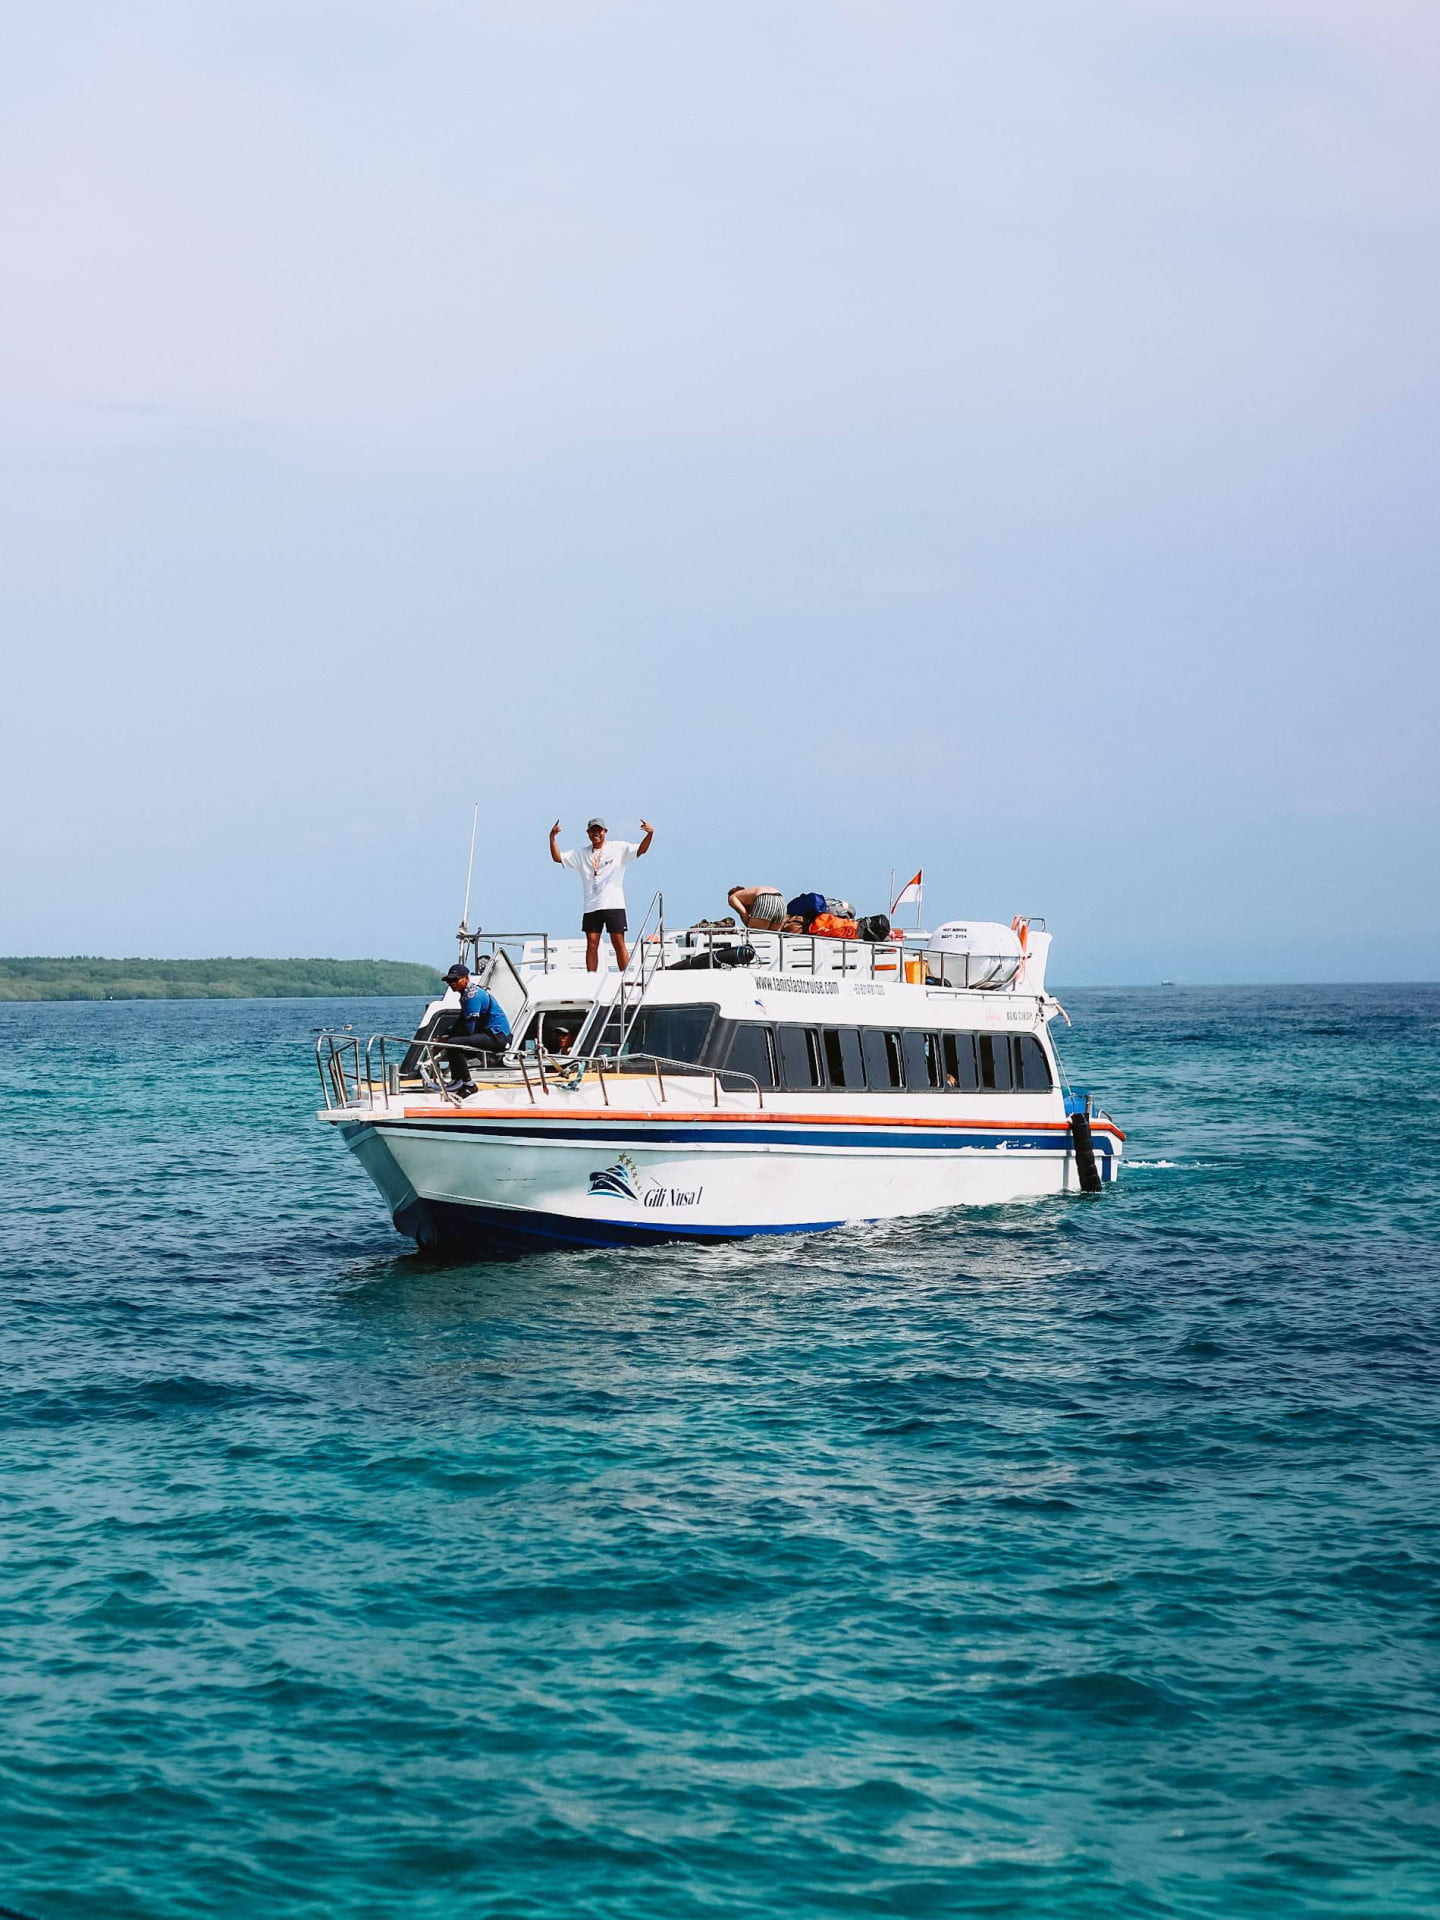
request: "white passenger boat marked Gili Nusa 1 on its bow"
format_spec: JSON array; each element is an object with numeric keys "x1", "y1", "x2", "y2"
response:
[{"x1": 317, "y1": 897, "x2": 1125, "y2": 1256}]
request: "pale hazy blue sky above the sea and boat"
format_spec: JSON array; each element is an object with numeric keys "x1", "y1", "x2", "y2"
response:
[{"x1": 0, "y1": 0, "x2": 1440, "y2": 983}]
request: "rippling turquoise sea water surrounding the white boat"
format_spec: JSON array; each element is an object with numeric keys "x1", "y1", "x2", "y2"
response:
[{"x1": 0, "y1": 987, "x2": 1440, "y2": 1920}]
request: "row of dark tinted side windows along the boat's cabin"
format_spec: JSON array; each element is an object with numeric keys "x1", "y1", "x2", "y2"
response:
[{"x1": 626, "y1": 1006, "x2": 1054, "y2": 1092}]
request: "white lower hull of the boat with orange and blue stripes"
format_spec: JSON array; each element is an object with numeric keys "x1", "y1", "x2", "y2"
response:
[{"x1": 342, "y1": 1112, "x2": 1121, "y2": 1256}]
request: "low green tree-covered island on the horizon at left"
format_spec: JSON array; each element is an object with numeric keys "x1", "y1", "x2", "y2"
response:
[{"x1": 0, "y1": 954, "x2": 442, "y2": 1000}]
